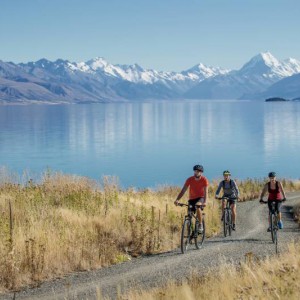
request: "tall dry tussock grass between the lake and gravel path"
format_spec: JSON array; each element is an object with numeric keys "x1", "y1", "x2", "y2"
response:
[{"x1": 0, "y1": 168, "x2": 298, "y2": 291}]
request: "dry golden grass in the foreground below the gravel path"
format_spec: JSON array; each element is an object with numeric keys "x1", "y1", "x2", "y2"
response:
[{"x1": 125, "y1": 244, "x2": 300, "y2": 300}]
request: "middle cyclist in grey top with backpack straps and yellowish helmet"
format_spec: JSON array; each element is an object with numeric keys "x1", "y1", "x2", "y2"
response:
[{"x1": 216, "y1": 170, "x2": 239, "y2": 230}]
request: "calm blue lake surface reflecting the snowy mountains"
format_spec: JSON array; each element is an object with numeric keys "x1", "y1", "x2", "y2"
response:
[{"x1": 0, "y1": 101, "x2": 300, "y2": 187}]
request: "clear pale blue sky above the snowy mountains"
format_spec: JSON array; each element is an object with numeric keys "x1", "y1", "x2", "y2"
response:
[{"x1": 0, "y1": 0, "x2": 300, "y2": 71}]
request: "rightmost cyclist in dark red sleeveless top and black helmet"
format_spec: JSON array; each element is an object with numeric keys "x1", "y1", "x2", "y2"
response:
[{"x1": 259, "y1": 172, "x2": 286, "y2": 232}]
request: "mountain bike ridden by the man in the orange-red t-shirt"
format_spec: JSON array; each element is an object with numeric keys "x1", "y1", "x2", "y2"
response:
[{"x1": 178, "y1": 203, "x2": 205, "y2": 254}]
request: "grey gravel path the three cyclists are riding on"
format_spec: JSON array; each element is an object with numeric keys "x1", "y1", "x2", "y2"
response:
[{"x1": 0, "y1": 193, "x2": 300, "y2": 299}]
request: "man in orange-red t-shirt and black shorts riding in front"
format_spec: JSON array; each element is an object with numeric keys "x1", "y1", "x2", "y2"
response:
[{"x1": 174, "y1": 165, "x2": 209, "y2": 232}]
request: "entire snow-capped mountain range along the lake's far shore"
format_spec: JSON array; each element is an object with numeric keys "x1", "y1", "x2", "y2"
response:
[{"x1": 0, "y1": 52, "x2": 300, "y2": 103}]
